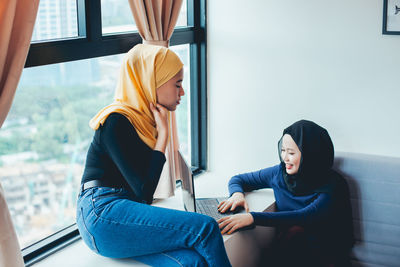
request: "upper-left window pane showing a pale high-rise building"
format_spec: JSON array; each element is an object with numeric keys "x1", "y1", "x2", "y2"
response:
[{"x1": 32, "y1": 0, "x2": 78, "y2": 41}]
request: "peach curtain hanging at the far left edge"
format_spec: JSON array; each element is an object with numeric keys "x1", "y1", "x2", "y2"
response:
[{"x1": 0, "y1": 0, "x2": 39, "y2": 267}]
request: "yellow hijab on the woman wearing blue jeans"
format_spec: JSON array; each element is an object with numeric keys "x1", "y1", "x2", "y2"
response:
[{"x1": 89, "y1": 44, "x2": 183, "y2": 148}]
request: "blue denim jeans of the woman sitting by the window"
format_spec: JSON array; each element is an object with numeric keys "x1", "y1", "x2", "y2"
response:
[{"x1": 77, "y1": 187, "x2": 231, "y2": 267}]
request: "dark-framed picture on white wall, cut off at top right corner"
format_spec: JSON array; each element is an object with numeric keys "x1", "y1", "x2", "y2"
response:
[{"x1": 382, "y1": 0, "x2": 400, "y2": 35}]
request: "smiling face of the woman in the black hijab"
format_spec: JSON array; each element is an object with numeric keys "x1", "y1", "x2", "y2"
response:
[{"x1": 281, "y1": 134, "x2": 301, "y2": 175}]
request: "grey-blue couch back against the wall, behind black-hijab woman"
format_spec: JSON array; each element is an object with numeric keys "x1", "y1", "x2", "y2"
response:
[{"x1": 334, "y1": 152, "x2": 400, "y2": 267}]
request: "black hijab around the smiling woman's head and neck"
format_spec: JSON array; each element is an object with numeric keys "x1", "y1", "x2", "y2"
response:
[{"x1": 278, "y1": 120, "x2": 334, "y2": 196}]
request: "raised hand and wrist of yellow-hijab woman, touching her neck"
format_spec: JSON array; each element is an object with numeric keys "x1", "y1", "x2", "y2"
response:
[{"x1": 150, "y1": 103, "x2": 168, "y2": 153}]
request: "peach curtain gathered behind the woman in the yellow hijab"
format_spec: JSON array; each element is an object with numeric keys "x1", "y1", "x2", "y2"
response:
[{"x1": 129, "y1": 0, "x2": 182, "y2": 198}]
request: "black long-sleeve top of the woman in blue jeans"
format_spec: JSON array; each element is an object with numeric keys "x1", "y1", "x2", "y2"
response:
[{"x1": 82, "y1": 113, "x2": 166, "y2": 204}]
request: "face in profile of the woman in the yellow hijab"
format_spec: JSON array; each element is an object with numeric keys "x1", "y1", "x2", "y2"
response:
[{"x1": 156, "y1": 68, "x2": 185, "y2": 111}]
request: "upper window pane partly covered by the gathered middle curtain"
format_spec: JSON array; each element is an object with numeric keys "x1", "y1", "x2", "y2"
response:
[{"x1": 101, "y1": 0, "x2": 187, "y2": 34}]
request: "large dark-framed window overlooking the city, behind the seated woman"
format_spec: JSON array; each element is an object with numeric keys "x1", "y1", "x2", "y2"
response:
[{"x1": 0, "y1": 0, "x2": 206, "y2": 264}]
